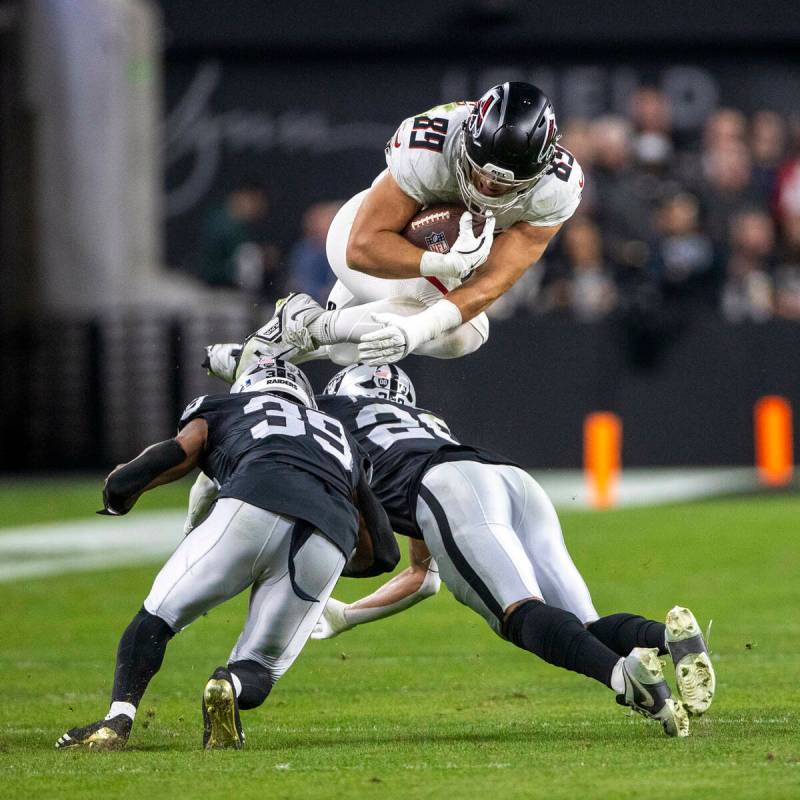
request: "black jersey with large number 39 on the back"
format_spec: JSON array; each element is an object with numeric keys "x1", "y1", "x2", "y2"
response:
[{"x1": 178, "y1": 392, "x2": 369, "y2": 558}]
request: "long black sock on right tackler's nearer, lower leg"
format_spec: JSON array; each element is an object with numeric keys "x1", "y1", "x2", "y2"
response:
[{"x1": 505, "y1": 600, "x2": 619, "y2": 687}]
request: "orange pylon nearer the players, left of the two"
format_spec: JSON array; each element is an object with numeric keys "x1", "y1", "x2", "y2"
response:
[{"x1": 583, "y1": 411, "x2": 622, "y2": 508}]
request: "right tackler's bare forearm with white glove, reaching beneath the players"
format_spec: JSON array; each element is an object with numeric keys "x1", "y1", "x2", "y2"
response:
[{"x1": 311, "y1": 539, "x2": 440, "y2": 639}]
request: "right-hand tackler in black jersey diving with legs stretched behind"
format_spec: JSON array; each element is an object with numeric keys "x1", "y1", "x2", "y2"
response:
[{"x1": 312, "y1": 365, "x2": 714, "y2": 736}]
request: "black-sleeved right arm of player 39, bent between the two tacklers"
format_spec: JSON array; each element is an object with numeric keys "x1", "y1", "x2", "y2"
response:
[{"x1": 342, "y1": 471, "x2": 400, "y2": 578}]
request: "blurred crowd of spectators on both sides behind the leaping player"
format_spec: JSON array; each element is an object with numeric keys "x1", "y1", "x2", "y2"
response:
[{"x1": 191, "y1": 86, "x2": 800, "y2": 336}]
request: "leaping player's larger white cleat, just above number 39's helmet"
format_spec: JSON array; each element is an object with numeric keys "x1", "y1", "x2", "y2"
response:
[{"x1": 235, "y1": 292, "x2": 324, "y2": 378}]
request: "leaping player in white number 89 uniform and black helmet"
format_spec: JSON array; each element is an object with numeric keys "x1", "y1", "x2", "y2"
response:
[{"x1": 209, "y1": 82, "x2": 584, "y2": 380}]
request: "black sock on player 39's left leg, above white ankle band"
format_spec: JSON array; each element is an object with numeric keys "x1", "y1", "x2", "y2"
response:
[{"x1": 111, "y1": 608, "x2": 175, "y2": 706}]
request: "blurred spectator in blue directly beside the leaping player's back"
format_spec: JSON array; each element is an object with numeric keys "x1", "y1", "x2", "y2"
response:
[{"x1": 288, "y1": 202, "x2": 341, "y2": 303}]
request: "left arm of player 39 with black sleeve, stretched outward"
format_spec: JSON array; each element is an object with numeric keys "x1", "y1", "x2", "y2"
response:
[{"x1": 98, "y1": 418, "x2": 208, "y2": 516}]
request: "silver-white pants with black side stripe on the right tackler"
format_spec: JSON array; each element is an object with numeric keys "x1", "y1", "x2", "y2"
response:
[{"x1": 417, "y1": 461, "x2": 598, "y2": 634}]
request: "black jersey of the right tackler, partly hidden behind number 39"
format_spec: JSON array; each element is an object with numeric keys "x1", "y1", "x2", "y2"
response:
[{"x1": 316, "y1": 395, "x2": 513, "y2": 539}]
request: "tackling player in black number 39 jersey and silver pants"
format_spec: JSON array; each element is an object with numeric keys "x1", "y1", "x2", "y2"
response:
[{"x1": 56, "y1": 358, "x2": 400, "y2": 750}]
